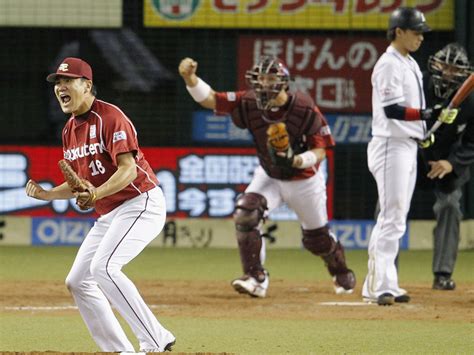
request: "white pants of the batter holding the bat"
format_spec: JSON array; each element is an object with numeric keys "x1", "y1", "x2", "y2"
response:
[{"x1": 362, "y1": 137, "x2": 418, "y2": 300}]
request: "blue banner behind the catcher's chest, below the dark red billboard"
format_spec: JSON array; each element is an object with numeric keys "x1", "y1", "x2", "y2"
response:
[{"x1": 193, "y1": 110, "x2": 372, "y2": 145}]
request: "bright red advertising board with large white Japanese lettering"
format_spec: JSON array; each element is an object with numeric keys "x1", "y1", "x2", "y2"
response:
[{"x1": 0, "y1": 146, "x2": 333, "y2": 220}]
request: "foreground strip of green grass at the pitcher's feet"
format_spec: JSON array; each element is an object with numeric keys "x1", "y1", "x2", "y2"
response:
[{"x1": 0, "y1": 314, "x2": 474, "y2": 354}]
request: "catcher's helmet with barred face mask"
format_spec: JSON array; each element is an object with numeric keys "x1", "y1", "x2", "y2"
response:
[{"x1": 245, "y1": 56, "x2": 290, "y2": 110}]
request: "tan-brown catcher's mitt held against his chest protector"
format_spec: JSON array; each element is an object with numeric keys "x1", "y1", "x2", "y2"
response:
[{"x1": 267, "y1": 122, "x2": 295, "y2": 168}]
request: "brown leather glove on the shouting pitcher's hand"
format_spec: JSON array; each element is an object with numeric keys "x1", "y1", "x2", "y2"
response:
[{"x1": 58, "y1": 159, "x2": 97, "y2": 210}]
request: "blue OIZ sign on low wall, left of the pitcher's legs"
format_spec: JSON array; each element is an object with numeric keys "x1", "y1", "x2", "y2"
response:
[{"x1": 31, "y1": 217, "x2": 95, "y2": 246}]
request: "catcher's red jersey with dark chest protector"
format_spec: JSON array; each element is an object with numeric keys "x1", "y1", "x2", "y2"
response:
[{"x1": 215, "y1": 91, "x2": 335, "y2": 180}]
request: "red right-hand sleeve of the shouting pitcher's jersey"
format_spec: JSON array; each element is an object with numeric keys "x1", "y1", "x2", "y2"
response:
[{"x1": 103, "y1": 109, "x2": 139, "y2": 165}]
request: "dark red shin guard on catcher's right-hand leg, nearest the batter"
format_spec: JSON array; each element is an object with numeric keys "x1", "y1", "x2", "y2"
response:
[{"x1": 303, "y1": 226, "x2": 356, "y2": 294}]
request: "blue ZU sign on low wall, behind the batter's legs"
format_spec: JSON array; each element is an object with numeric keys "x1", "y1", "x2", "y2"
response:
[{"x1": 329, "y1": 220, "x2": 409, "y2": 250}]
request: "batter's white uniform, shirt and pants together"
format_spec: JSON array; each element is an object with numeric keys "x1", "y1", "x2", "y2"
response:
[{"x1": 362, "y1": 46, "x2": 426, "y2": 299}]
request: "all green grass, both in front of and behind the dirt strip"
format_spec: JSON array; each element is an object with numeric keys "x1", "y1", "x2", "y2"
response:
[{"x1": 0, "y1": 247, "x2": 474, "y2": 354}]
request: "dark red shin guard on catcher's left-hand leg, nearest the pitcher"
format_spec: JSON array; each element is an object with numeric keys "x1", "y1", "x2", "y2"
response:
[{"x1": 234, "y1": 193, "x2": 267, "y2": 281}]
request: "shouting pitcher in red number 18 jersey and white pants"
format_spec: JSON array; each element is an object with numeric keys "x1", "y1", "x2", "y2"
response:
[{"x1": 26, "y1": 58, "x2": 175, "y2": 352}]
